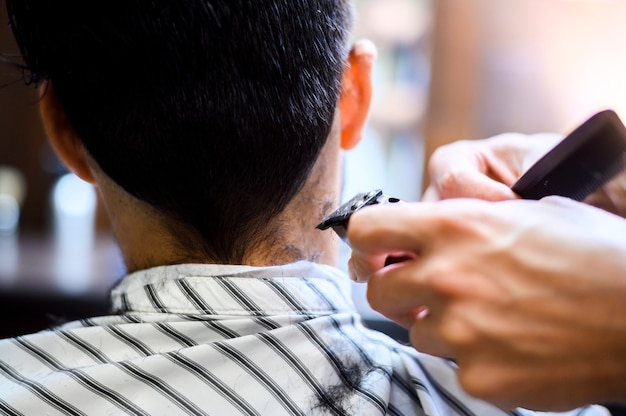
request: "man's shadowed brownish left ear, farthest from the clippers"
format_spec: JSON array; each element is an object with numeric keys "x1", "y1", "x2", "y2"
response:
[{"x1": 39, "y1": 81, "x2": 95, "y2": 183}]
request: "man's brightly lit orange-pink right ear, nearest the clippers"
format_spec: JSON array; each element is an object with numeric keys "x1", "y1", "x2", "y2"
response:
[{"x1": 339, "y1": 40, "x2": 377, "y2": 150}]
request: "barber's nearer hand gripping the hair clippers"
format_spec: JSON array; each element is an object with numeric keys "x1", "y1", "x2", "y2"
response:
[{"x1": 348, "y1": 197, "x2": 626, "y2": 410}]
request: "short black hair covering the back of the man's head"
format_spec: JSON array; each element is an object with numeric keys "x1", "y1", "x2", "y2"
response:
[{"x1": 7, "y1": 0, "x2": 351, "y2": 263}]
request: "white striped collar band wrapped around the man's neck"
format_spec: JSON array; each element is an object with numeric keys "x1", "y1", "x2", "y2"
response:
[{"x1": 111, "y1": 262, "x2": 355, "y2": 316}]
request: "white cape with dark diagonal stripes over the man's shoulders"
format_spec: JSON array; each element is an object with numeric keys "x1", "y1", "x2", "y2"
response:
[{"x1": 0, "y1": 262, "x2": 607, "y2": 416}]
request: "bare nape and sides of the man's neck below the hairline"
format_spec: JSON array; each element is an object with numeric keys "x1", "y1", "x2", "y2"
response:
[{"x1": 97, "y1": 132, "x2": 341, "y2": 272}]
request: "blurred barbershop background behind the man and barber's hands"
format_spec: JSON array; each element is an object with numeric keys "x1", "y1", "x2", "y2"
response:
[{"x1": 0, "y1": 0, "x2": 626, "y2": 336}]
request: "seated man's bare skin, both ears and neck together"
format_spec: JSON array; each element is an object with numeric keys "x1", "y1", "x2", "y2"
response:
[{"x1": 40, "y1": 41, "x2": 376, "y2": 271}]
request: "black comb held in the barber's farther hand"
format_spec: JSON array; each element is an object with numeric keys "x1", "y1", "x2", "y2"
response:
[{"x1": 511, "y1": 110, "x2": 626, "y2": 201}]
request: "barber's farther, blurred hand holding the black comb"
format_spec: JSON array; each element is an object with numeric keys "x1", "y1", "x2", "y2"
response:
[{"x1": 423, "y1": 133, "x2": 562, "y2": 201}]
